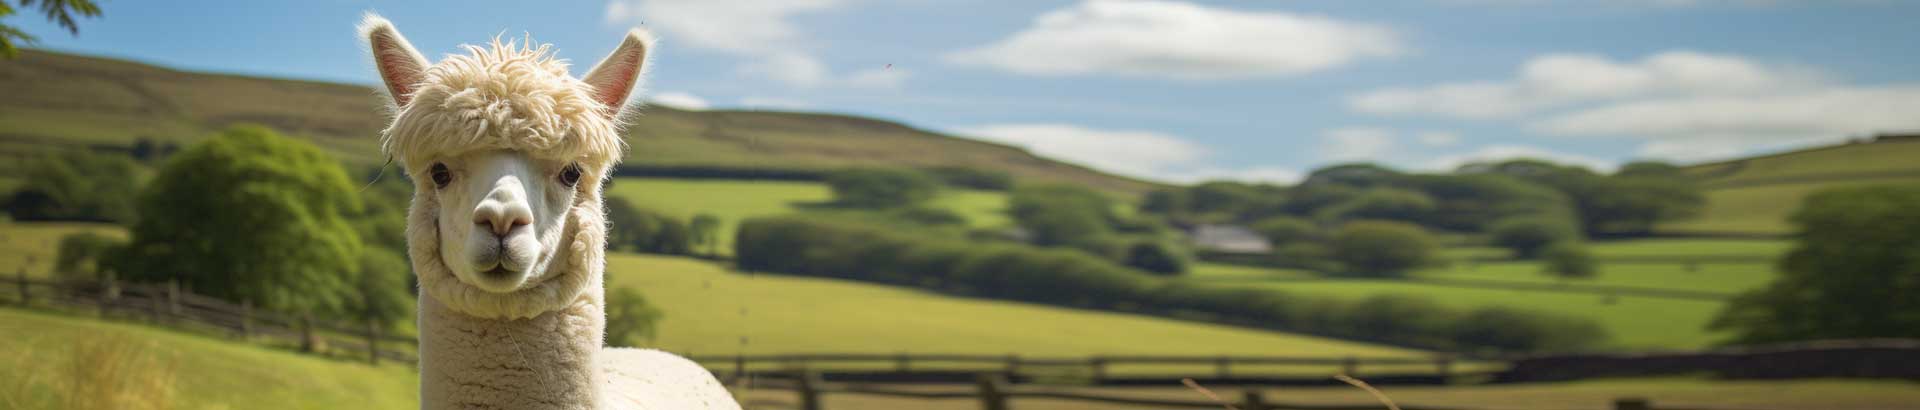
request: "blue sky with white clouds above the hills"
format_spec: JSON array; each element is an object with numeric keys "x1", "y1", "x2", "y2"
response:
[{"x1": 15, "y1": 0, "x2": 1920, "y2": 184}]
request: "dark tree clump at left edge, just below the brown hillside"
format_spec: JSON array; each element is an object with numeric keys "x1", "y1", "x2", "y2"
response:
[{"x1": 8, "y1": 151, "x2": 140, "y2": 222}]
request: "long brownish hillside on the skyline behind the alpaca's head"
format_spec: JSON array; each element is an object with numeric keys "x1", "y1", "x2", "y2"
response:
[{"x1": 0, "y1": 50, "x2": 1154, "y2": 194}]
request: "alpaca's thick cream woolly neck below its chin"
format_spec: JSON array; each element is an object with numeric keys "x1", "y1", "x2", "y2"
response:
[{"x1": 419, "y1": 295, "x2": 607, "y2": 410}]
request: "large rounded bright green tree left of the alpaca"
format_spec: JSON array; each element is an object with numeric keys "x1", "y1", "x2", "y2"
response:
[{"x1": 119, "y1": 126, "x2": 363, "y2": 312}]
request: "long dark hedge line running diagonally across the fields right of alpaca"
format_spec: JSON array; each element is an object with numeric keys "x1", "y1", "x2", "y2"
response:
[{"x1": 733, "y1": 216, "x2": 1607, "y2": 353}]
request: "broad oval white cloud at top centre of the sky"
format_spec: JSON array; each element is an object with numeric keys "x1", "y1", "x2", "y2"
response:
[{"x1": 945, "y1": 0, "x2": 1404, "y2": 79}]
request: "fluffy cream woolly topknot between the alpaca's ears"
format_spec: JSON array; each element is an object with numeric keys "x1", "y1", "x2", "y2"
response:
[{"x1": 382, "y1": 36, "x2": 626, "y2": 171}]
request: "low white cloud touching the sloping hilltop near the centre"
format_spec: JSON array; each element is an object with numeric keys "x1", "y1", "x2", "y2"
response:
[{"x1": 954, "y1": 123, "x2": 1300, "y2": 182}]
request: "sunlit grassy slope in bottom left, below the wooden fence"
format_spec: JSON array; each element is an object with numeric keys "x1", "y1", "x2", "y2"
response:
[{"x1": 0, "y1": 308, "x2": 419, "y2": 408}]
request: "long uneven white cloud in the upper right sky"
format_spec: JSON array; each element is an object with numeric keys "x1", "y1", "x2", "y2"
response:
[{"x1": 1346, "y1": 50, "x2": 1822, "y2": 119}]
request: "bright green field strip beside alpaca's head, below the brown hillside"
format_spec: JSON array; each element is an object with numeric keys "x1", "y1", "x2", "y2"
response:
[{"x1": 607, "y1": 178, "x2": 1010, "y2": 255}]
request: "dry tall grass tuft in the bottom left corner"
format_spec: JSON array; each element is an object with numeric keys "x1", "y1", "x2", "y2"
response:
[{"x1": 0, "y1": 333, "x2": 180, "y2": 410}]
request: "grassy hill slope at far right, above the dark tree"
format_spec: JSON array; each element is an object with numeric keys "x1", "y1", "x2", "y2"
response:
[{"x1": 1659, "y1": 136, "x2": 1920, "y2": 234}]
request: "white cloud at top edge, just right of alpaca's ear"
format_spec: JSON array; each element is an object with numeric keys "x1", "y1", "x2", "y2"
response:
[{"x1": 605, "y1": 0, "x2": 906, "y2": 88}]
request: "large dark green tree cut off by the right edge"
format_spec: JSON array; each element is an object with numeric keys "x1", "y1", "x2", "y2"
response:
[{"x1": 1711, "y1": 186, "x2": 1920, "y2": 343}]
